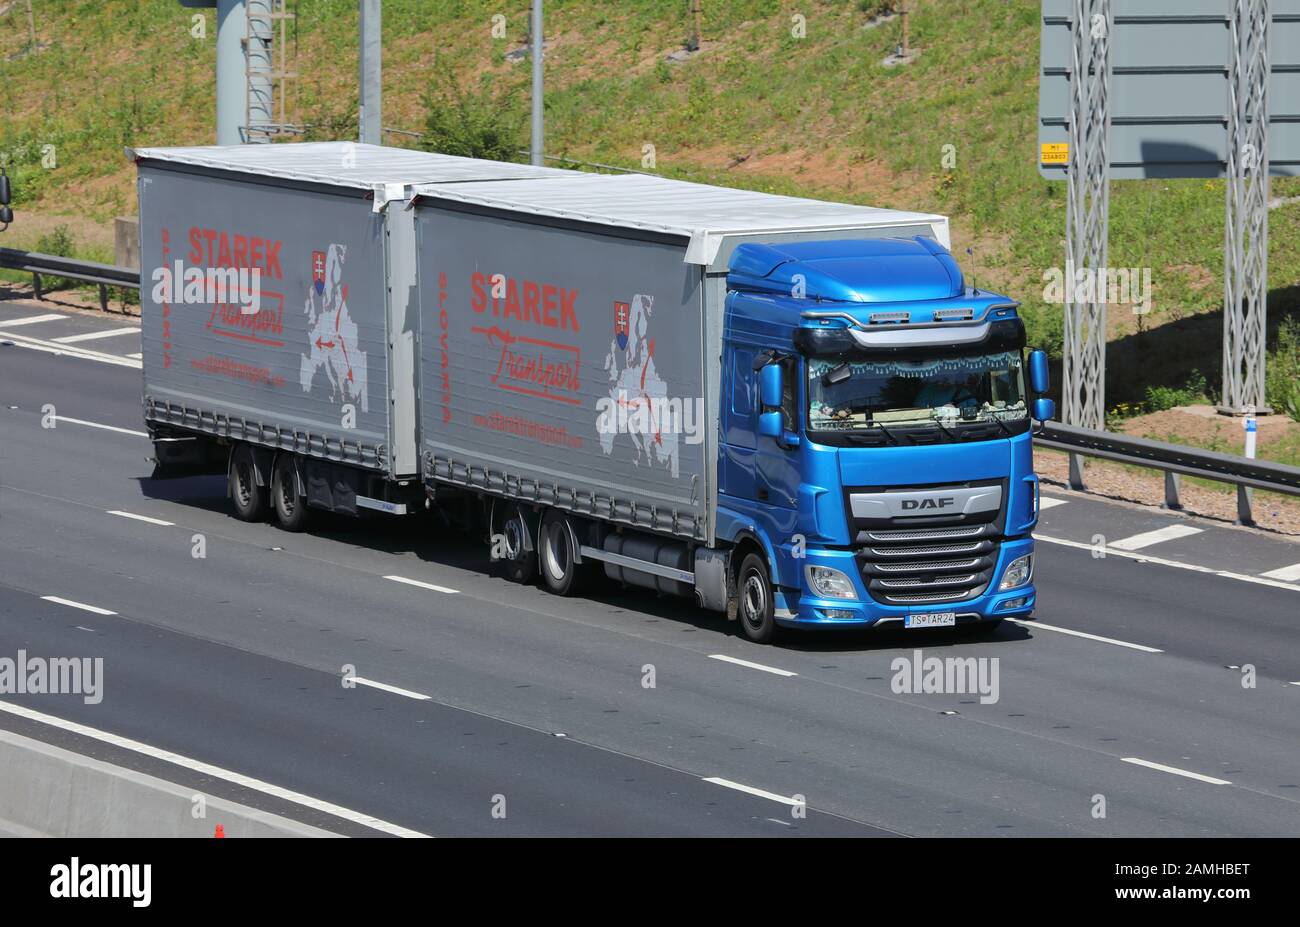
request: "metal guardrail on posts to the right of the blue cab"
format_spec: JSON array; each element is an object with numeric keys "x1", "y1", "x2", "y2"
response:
[{"x1": 1034, "y1": 423, "x2": 1300, "y2": 525}]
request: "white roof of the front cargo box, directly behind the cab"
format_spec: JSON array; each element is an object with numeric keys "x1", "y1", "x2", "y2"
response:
[{"x1": 415, "y1": 172, "x2": 950, "y2": 265}]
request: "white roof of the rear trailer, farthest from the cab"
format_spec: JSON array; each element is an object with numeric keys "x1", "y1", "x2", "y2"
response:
[{"x1": 126, "y1": 142, "x2": 572, "y2": 190}]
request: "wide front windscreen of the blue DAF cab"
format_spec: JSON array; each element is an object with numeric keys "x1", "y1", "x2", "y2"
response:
[{"x1": 807, "y1": 351, "x2": 1028, "y2": 433}]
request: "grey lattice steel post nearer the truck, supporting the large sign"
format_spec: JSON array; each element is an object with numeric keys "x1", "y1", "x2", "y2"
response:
[{"x1": 1062, "y1": 0, "x2": 1114, "y2": 486}]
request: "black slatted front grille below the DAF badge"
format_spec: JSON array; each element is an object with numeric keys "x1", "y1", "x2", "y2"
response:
[{"x1": 854, "y1": 484, "x2": 1006, "y2": 606}]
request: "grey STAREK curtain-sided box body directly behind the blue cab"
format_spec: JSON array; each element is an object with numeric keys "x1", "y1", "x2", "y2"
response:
[{"x1": 410, "y1": 174, "x2": 949, "y2": 592}]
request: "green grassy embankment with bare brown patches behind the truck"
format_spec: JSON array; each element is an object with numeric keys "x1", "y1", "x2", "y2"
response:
[{"x1": 0, "y1": 0, "x2": 1300, "y2": 418}]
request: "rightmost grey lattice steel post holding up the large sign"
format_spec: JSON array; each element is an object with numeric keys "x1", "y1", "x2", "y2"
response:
[{"x1": 1219, "y1": 0, "x2": 1273, "y2": 415}]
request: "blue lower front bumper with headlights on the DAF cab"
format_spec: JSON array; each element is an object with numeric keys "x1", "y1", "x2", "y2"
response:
[{"x1": 776, "y1": 538, "x2": 1037, "y2": 628}]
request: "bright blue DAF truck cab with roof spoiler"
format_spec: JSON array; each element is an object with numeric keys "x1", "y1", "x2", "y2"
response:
[{"x1": 718, "y1": 237, "x2": 1054, "y2": 641}]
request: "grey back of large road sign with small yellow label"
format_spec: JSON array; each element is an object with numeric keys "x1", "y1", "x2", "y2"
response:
[{"x1": 1037, "y1": 0, "x2": 1300, "y2": 181}]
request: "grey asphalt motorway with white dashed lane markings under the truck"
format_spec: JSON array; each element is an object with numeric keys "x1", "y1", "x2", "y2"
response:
[{"x1": 0, "y1": 312, "x2": 1300, "y2": 836}]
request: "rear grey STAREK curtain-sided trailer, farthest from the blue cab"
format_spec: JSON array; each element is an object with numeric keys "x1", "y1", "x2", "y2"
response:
[{"x1": 127, "y1": 142, "x2": 567, "y2": 529}]
